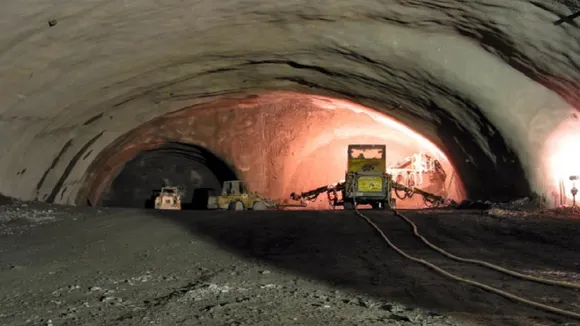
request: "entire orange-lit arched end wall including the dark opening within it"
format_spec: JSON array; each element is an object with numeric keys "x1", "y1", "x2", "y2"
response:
[{"x1": 78, "y1": 92, "x2": 466, "y2": 209}]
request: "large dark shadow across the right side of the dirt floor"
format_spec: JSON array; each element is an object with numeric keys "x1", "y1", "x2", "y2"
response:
[{"x1": 144, "y1": 211, "x2": 580, "y2": 325}]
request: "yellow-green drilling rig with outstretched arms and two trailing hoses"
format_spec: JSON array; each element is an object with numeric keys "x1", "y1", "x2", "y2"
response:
[{"x1": 290, "y1": 144, "x2": 445, "y2": 210}]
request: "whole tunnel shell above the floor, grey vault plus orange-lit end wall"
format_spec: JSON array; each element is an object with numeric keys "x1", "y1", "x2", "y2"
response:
[{"x1": 0, "y1": 0, "x2": 580, "y2": 207}]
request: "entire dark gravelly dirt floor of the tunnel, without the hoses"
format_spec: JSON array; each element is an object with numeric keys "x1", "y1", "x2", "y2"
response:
[{"x1": 0, "y1": 202, "x2": 580, "y2": 326}]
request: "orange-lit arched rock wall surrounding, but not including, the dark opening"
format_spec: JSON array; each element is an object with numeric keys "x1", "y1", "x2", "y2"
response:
[{"x1": 77, "y1": 91, "x2": 483, "y2": 208}]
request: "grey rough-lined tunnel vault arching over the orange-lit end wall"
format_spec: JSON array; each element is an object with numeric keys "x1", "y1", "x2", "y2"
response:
[{"x1": 0, "y1": 0, "x2": 580, "y2": 202}]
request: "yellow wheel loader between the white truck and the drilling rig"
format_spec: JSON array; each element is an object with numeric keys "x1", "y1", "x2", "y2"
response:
[{"x1": 207, "y1": 180, "x2": 276, "y2": 211}]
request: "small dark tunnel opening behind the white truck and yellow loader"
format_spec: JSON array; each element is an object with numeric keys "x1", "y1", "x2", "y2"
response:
[{"x1": 101, "y1": 142, "x2": 238, "y2": 209}]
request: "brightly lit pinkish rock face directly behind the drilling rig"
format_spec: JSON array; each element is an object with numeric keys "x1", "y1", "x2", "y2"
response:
[{"x1": 280, "y1": 101, "x2": 465, "y2": 209}]
